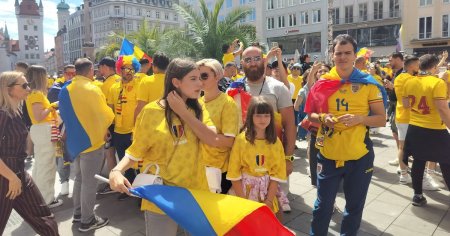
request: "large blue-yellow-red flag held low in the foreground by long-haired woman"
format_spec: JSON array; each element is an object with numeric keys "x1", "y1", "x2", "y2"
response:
[{"x1": 130, "y1": 185, "x2": 294, "y2": 236}]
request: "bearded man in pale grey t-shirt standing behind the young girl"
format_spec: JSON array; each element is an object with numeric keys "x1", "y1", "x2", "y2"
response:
[{"x1": 241, "y1": 46, "x2": 297, "y2": 211}]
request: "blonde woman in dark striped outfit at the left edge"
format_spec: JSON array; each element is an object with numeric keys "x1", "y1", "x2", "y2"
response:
[{"x1": 0, "y1": 71, "x2": 58, "y2": 235}]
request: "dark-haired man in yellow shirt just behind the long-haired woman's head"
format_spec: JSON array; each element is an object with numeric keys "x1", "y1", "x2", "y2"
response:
[{"x1": 134, "y1": 52, "x2": 170, "y2": 119}]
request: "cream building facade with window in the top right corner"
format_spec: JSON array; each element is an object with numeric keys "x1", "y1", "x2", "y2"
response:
[{"x1": 401, "y1": 0, "x2": 450, "y2": 56}]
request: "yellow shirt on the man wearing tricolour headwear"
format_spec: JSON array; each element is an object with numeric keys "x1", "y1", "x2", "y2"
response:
[{"x1": 106, "y1": 79, "x2": 137, "y2": 134}]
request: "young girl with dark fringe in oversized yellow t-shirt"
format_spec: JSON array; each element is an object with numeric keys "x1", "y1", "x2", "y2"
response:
[{"x1": 227, "y1": 97, "x2": 287, "y2": 213}]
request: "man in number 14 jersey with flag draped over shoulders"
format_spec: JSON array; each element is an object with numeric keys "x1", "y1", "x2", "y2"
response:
[{"x1": 305, "y1": 34, "x2": 387, "y2": 236}]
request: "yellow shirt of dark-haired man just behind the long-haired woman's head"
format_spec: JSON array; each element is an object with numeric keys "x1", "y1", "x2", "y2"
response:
[{"x1": 137, "y1": 74, "x2": 166, "y2": 103}]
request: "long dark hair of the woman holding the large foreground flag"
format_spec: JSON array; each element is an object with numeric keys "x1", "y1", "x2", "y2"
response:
[{"x1": 162, "y1": 58, "x2": 202, "y2": 137}]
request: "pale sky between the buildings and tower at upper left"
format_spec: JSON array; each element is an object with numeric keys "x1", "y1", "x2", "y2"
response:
[{"x1": 0, "y1": 0, "x2": 83, "y2": 51}]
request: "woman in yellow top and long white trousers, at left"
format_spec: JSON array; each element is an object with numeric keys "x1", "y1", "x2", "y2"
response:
[{"x1": 26, "y1": 65, "x2": 63, "y2": 208}]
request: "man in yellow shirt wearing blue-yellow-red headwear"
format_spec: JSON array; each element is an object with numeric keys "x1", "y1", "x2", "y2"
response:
[{"x1": 107, "y1": 56, "x2": 141, "y2": 200}]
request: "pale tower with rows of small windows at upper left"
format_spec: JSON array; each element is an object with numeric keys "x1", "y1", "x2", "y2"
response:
[{"x1": 15, "y1": 0, "x2": 44, "y2": 65}]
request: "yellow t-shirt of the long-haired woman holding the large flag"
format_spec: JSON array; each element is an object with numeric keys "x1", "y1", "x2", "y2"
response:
[{"x1": 126, "y1": 101, "x2": 209, "y2": 214}]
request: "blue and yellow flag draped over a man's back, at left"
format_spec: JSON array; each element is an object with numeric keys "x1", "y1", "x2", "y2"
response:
[{"x1": 59, "y1": 76, "x2": 114, "y2": 161}]
